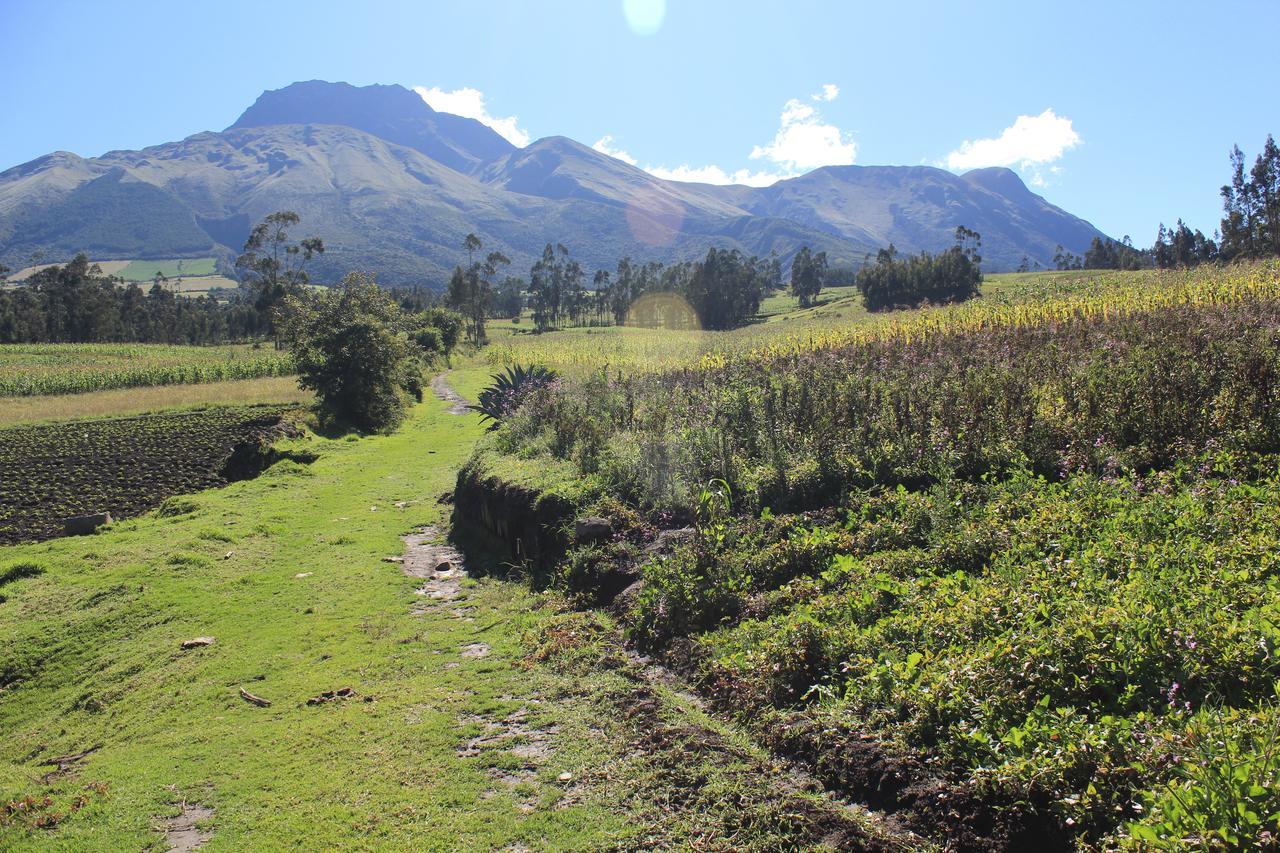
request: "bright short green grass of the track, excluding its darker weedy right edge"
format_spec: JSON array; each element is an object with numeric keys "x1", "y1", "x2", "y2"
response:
[{"x1": 0, "y1": 368, "x2": 629, "y2": 849}]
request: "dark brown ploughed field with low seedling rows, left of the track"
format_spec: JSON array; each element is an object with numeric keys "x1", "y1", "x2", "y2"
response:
[{"x1": 0, "y1": 406, "x2": 296, "y2": 544}]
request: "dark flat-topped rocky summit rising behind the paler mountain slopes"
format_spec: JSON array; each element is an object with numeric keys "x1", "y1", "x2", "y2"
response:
[{"x1": 227, "y1": 79, "x2": 515, "y2": 174}]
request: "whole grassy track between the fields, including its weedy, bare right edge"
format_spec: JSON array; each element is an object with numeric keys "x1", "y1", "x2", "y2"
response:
[{"x1": 0, "y1": 361, "x2": 901, "y2": 850}]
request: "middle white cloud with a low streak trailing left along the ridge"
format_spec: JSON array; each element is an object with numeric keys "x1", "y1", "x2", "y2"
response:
[{"x1": 591, "y1": 83, "x2": 858, "y2": 187}]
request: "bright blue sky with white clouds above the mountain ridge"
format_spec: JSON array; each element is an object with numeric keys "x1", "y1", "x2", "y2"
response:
[{"x1": 0, "y1": 0, "x2": 1280, "y2": 245}]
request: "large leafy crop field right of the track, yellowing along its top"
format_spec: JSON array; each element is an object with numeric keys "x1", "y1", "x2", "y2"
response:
[{"x1": 471, "y1": 263, "x2": 1280, "y2": 849}]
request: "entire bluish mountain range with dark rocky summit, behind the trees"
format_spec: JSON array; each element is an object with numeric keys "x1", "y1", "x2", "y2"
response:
[{"x1": 0, "y1": 81, "x2": 1100, "y2": 284}]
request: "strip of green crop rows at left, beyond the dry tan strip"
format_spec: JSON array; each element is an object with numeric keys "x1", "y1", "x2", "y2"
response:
[{"x1": 0, "y1": 343, "x2": 293, "y2": 397}]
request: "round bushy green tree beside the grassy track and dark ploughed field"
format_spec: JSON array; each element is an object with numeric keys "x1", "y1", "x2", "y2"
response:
[{"x1": 282, "y1": 273, "x2": 422, "y2": 432}]
